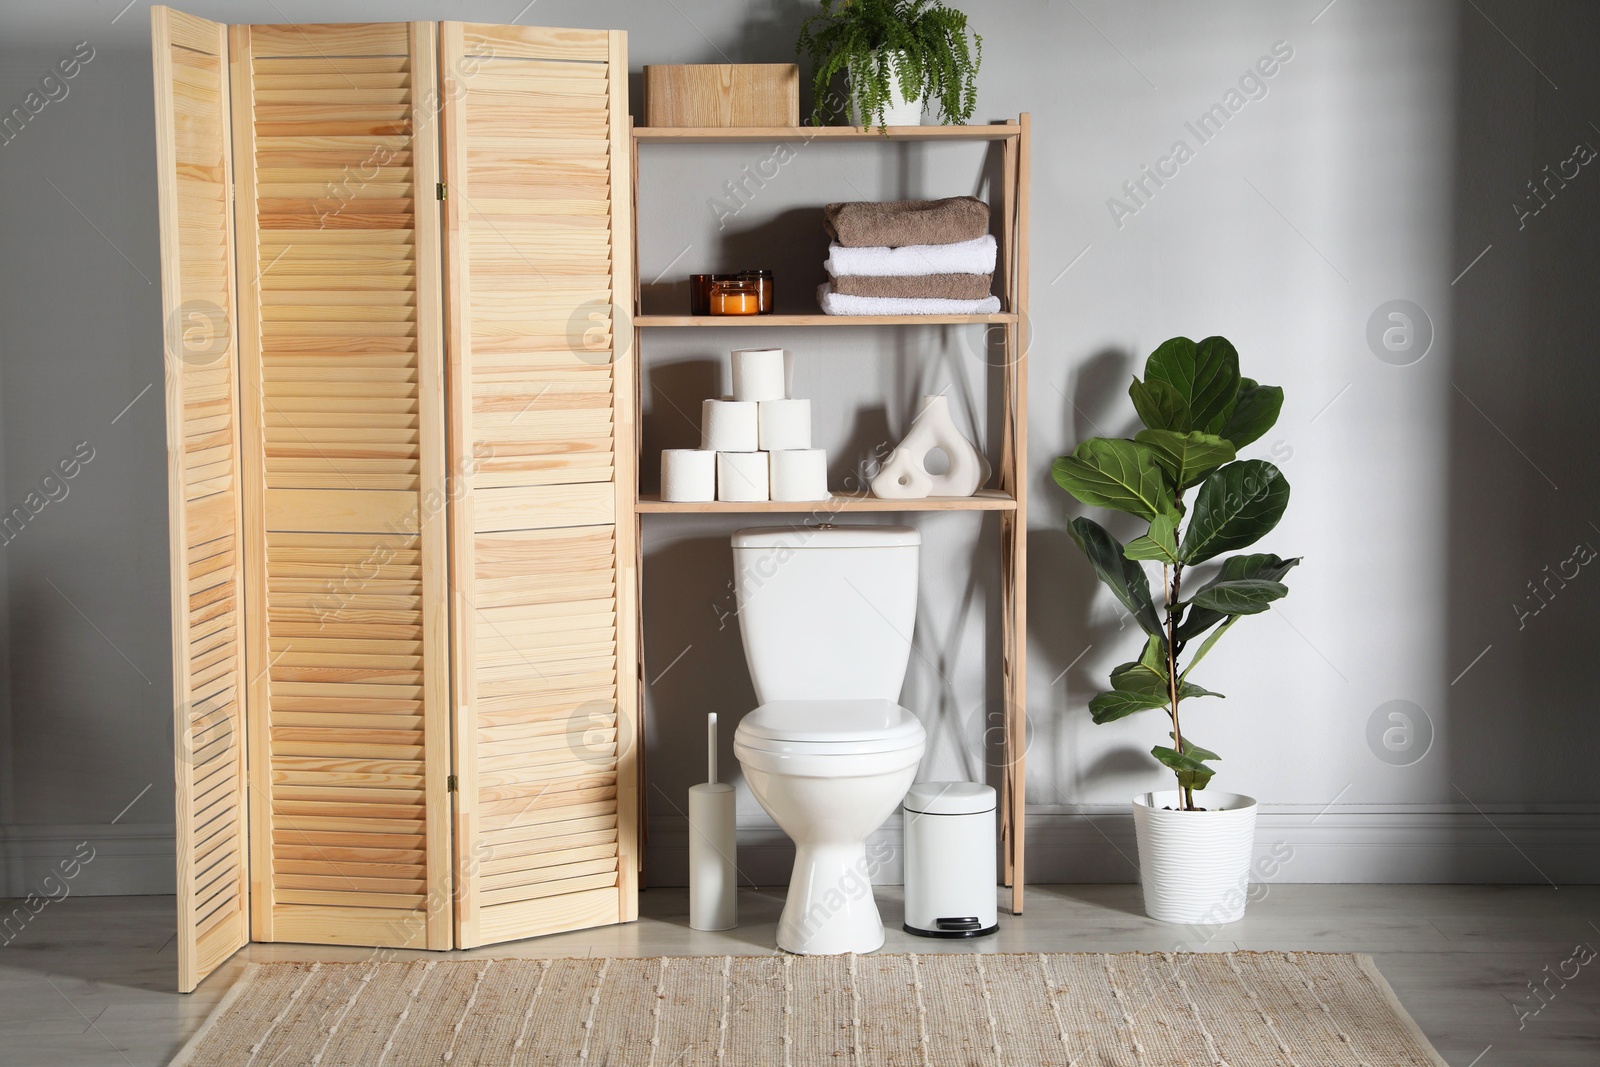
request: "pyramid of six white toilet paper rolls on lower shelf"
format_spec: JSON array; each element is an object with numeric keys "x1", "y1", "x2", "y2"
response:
[{"x1": 661, "y1": 349, "x2": 829, "y2": 502}]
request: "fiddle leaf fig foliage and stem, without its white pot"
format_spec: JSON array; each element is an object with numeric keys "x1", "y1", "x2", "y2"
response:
[{"x1": 1051, "y1": 338, "x2": 1299, "y2": 811}]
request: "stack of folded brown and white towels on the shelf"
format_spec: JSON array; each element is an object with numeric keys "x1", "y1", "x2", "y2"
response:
[{"x1": 818, "y1": 197, "x2": 1000, "y2": 315}]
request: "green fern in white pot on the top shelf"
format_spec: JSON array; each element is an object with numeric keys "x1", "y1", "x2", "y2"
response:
[{"x1": 795, "y1": 0, "x2": 984, "y2": 130}]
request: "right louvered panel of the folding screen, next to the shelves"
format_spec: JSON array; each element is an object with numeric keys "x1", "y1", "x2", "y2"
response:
[{"x1": 440, "y1": 22, "x2": 638, "y2": 945}]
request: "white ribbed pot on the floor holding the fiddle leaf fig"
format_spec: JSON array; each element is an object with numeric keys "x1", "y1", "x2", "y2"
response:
[{"x1": 1133, "y1": 789, "x2": 1256, "y2": 926}]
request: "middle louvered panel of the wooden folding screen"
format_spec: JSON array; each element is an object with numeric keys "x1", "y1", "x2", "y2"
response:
[{"x1": 234, "y1": 22, "x2": 451, "y2": 949}]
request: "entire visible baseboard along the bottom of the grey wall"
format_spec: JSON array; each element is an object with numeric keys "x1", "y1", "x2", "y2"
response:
[{"x1": 12, "y1": 805, "x2": 1600, "y2": 897}]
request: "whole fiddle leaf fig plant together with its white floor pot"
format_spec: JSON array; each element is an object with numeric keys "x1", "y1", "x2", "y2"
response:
[{"x1": 1051, "y1": 338, "x2": 1299, "y2": 923}]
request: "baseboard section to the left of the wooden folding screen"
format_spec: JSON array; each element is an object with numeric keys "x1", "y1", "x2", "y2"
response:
[{"x1": 0, "y1": 822, "x2": 178, "y2": 897}]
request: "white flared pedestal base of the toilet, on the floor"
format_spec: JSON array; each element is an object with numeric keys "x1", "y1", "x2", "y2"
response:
[{"x1": 778, "y1": 841, "x2": 883, "y2": 955}]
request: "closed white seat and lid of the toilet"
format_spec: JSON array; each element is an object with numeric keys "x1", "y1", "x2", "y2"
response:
[{"x1": 734, "y1": 701, "x2": 926, "y2": 757}]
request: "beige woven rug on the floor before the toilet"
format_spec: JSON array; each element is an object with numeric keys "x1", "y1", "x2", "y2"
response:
[{"x1": 173, "y1": 952, "x2": 1445, "y2": 1067}]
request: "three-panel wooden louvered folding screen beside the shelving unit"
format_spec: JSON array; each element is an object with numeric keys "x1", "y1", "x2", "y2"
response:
[{"x1": 152, "y1": 8, "x2": 638, "y2": 990}]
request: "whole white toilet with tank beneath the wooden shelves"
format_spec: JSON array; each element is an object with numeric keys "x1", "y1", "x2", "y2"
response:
[{"x1": 733, "y1": 525, "x2": 926, "y2": 955}]
